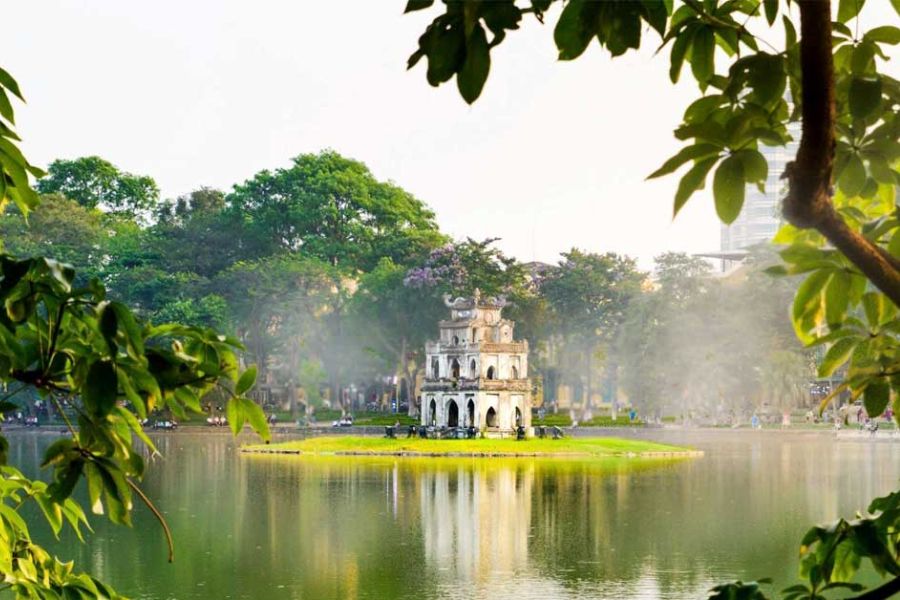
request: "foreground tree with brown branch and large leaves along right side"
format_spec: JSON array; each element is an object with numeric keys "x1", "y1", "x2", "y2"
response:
[{"x1": 406, "y1": 0, "x2": 900, "y2": 598}]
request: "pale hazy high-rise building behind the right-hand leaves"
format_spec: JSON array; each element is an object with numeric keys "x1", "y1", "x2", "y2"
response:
[{"x1": 720, "y1": 127, "x2": 800, "y2": 253}]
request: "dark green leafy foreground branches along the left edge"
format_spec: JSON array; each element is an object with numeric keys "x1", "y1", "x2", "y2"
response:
[{"x1": 0, "y1": 69, "x2": 269, "y2": 598}]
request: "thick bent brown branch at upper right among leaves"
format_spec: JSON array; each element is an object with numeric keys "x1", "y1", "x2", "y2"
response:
[{"x1": 783, "y1": 0, "x2": 900, "y2": 306}]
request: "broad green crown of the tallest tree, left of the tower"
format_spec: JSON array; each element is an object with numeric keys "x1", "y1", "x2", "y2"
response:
[{"x1": 227, "y1": 151, "x2": 442, "y2": 272}]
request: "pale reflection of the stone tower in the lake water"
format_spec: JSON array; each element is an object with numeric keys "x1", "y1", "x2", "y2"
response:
[{"x1": 420, "y1": 463, "x2": 534, "y2": 581}]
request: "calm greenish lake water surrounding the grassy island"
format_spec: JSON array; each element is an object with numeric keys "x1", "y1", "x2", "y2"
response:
[{"x1": 10, "y1": 432, "x2": 900, "y2": 600}]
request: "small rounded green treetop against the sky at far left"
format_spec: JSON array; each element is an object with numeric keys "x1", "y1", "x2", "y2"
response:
[{"x1": 36, "y1": 156, "x2": 159, "y2": 220}]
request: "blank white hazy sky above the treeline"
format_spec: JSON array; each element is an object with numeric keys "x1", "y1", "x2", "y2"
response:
[{"x1": 3, "y1": 0, "x2": 896, "y2": 266}]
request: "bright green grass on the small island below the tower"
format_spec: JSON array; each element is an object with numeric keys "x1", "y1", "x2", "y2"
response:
[{"x1": 242, "y1": 435, "x2": 699, "y2": 457}]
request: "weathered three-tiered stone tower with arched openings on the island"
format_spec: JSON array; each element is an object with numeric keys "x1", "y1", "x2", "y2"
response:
[{"x1": 422, "y1": 290, "x2": 531, "y2": 436}]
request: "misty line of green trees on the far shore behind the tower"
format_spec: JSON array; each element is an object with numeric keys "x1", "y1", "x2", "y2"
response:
[{"x1": 0, "y1": 151, "x2": 812, "y2": 413}]
